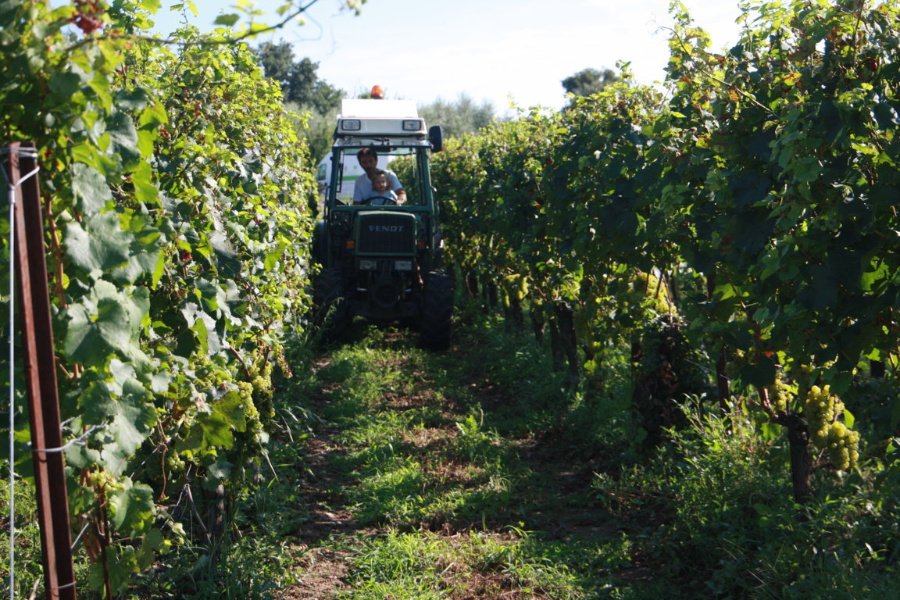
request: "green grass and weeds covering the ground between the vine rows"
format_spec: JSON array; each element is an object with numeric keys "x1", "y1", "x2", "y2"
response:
[{"x1": 19, "y1": 312, "x2": 900, "y2": 600}]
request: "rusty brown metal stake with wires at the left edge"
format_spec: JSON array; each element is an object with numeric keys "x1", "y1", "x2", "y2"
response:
[{"x1": 8, "y1": 143, "x2": 75, "y2": 600}]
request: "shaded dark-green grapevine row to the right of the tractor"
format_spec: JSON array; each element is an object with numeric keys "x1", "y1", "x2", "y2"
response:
[{"x1": 434, "y1": 0, "x2": 900, "y2": 499}]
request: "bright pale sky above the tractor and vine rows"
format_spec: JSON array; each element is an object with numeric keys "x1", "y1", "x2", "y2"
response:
[{"x1": 156, "y1": 0, "x2": 740, "y2": 114}]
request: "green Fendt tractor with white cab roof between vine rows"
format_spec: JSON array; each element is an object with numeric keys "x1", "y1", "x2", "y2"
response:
[{"x1": 313, "y1": 100, "x2": 453, "y2": 350}]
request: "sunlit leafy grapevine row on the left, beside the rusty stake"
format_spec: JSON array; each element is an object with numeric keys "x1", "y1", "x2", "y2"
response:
[{"x1": 0, "y1": 0, "x2": 315, "y2": 594}]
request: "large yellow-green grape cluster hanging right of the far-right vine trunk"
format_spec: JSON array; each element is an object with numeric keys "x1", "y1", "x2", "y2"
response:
[{"x1": 804, "y1": 385, "x2": 859, "y2": 471}]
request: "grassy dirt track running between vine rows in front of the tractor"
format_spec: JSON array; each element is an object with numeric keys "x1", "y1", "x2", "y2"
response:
[{"x1": 279, "y1": 334, "x2": 636, "y2": 599}]
